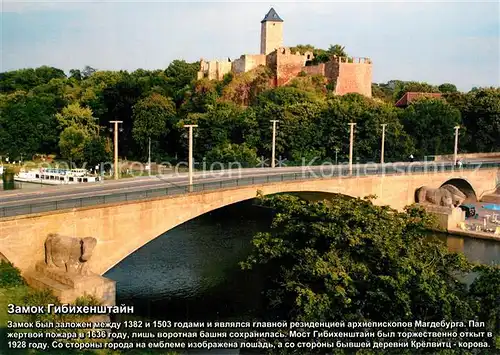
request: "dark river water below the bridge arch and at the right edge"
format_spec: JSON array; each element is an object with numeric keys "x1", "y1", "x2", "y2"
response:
[{"x1": 104, "y1": 196, "x2": 500, "y2": 321}]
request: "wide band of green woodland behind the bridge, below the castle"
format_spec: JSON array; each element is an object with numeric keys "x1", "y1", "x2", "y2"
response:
[{"x1": 0, "y1": 54, "x2": 500, "y2": 164}]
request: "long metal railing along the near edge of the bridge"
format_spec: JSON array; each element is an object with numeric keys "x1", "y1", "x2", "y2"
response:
[{"x1": 0, "y1": 162, "x2": 500, "y2": 218}]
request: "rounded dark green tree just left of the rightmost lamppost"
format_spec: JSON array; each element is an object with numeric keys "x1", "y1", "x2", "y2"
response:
[{"x1": 401, "y1": 98, "x2": 464, "y2": 156}]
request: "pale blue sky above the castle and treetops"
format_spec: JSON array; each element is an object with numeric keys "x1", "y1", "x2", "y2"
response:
[{"x1": 0, "y1": 0, "x2": 500, "y2": 91}]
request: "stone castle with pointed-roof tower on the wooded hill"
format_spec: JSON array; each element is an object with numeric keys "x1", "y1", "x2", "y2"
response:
[{"x1": 198, "y1": 8, "x2": 372, "y2": 97}]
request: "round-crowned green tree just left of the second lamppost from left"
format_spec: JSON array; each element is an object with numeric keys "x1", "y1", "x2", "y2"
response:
[{"x1": 132, "y1": 93, "x2": 176, "y2": 159}]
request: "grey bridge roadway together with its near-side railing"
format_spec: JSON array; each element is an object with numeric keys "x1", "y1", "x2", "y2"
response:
[{"x1": 0, "y1": 159, "x2": 500, "y2": 218}]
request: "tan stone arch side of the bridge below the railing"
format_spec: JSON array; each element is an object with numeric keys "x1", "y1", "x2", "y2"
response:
[{"x1": 0, "y1": 167, "x2": 500, "y2": 275}]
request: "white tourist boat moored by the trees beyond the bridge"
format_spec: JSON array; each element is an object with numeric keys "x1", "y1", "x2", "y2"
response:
[{"x1": 14, "y1": 168, "x2": 101, "y2": 185}]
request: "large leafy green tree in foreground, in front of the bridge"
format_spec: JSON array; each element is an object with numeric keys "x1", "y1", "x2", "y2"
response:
[{"x1": 241, "y1": 195, "x2": 500, "y2": 354}]
